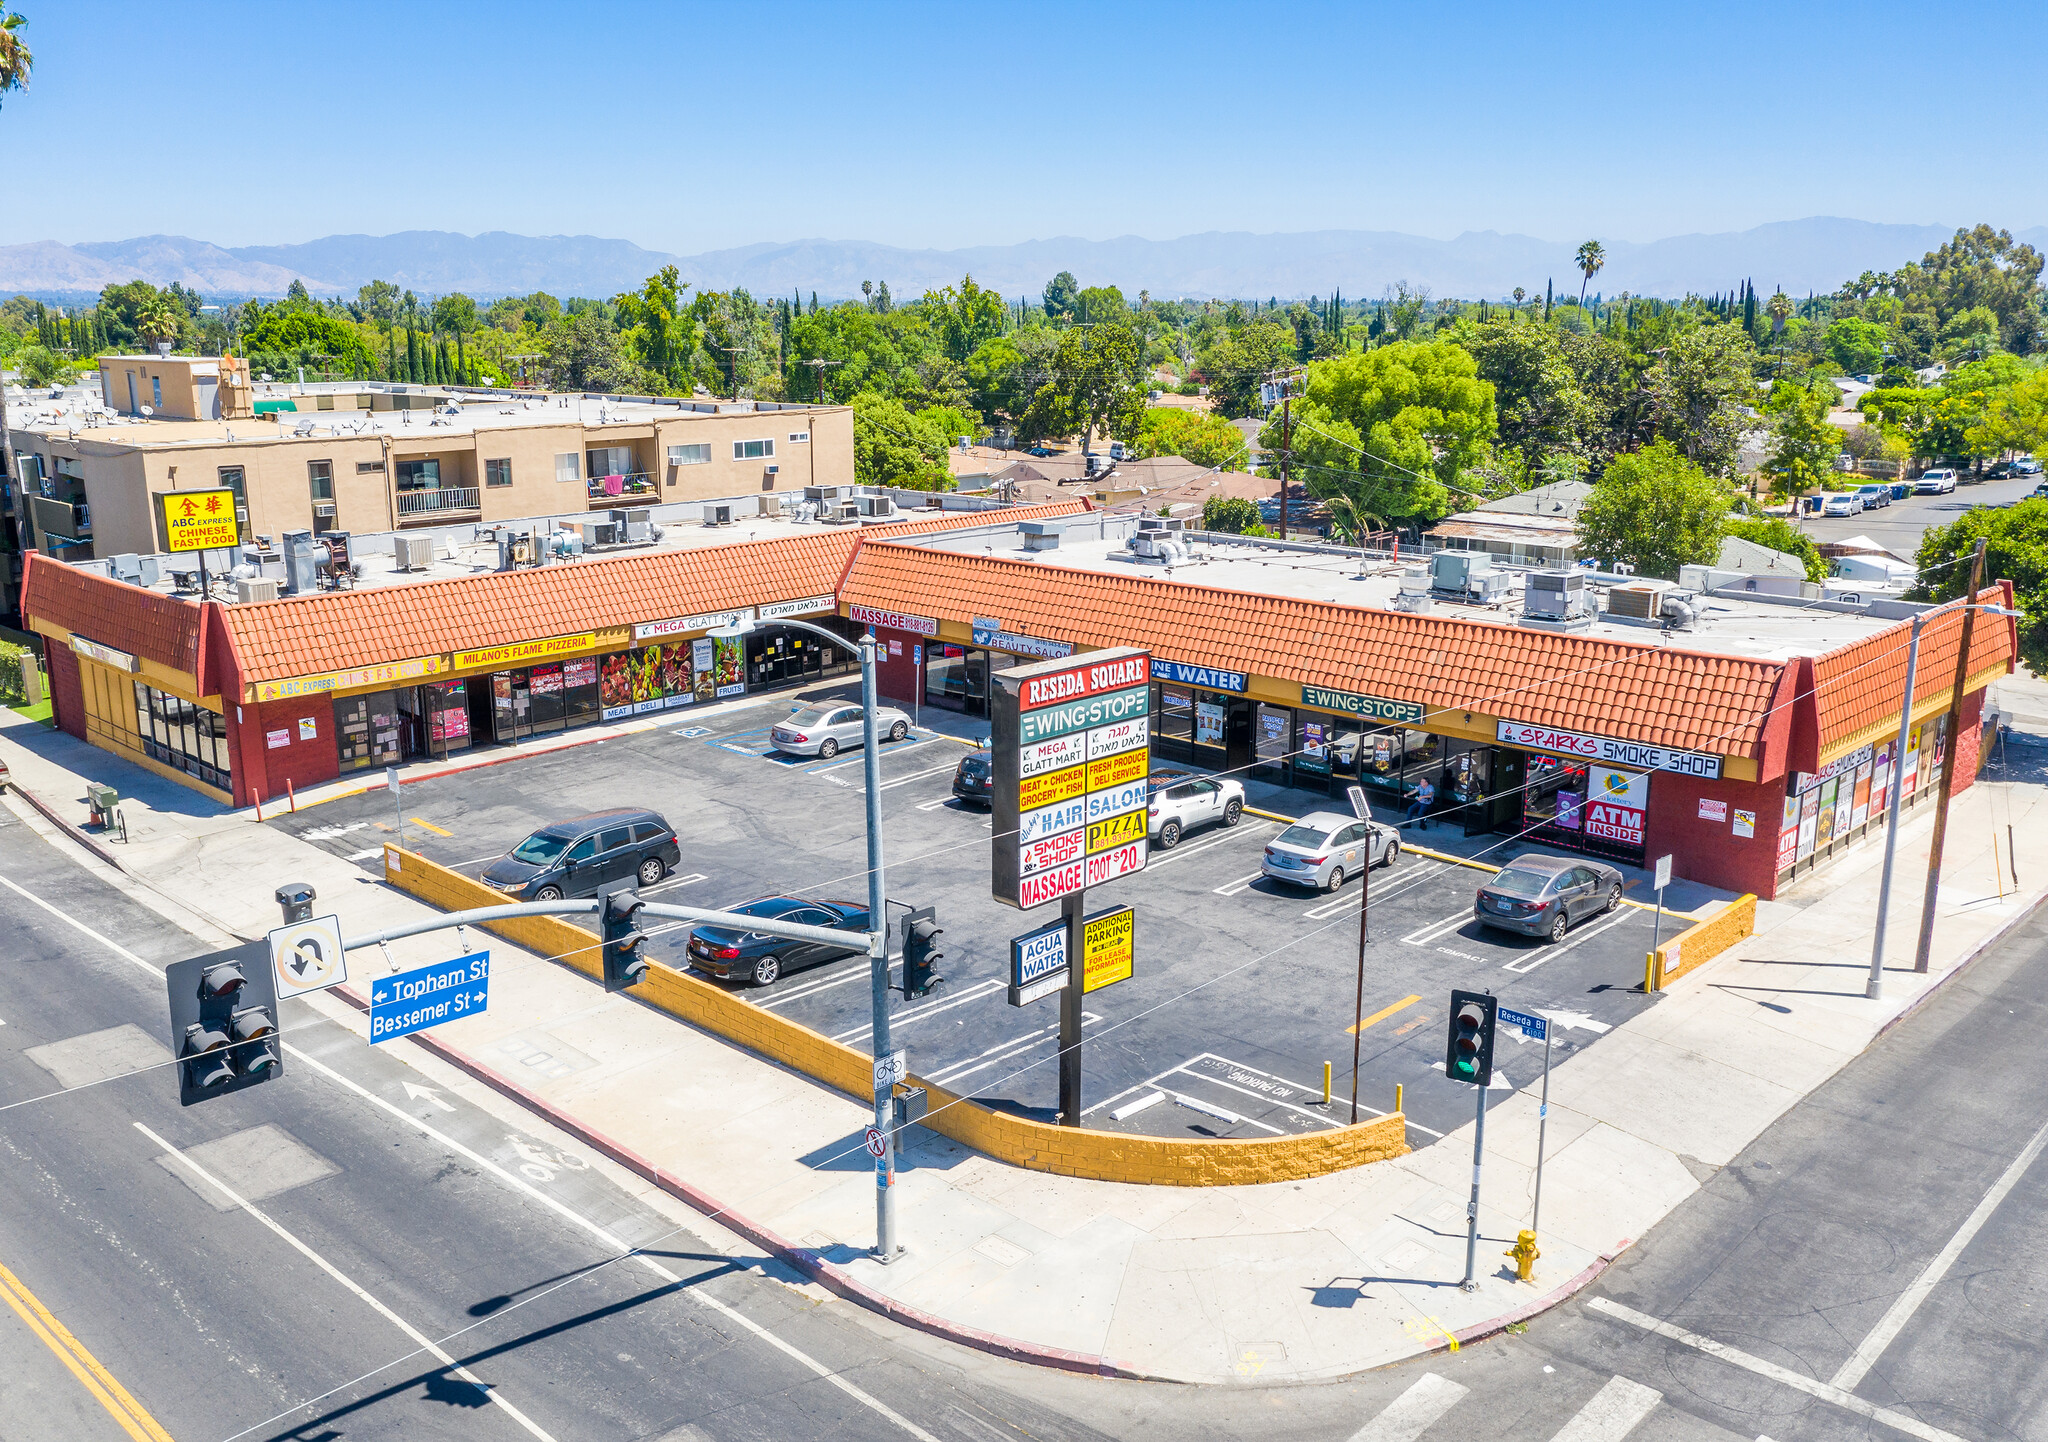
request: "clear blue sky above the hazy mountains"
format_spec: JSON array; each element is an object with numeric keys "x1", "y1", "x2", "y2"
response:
[{"x1": 0, "y1": 0, "x2": 2048, "y2": 254}]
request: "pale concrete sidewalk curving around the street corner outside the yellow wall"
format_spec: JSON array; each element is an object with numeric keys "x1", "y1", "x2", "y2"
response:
[{"x1": 0, "y1": 696, "x2": 2048, "y2": 1383}]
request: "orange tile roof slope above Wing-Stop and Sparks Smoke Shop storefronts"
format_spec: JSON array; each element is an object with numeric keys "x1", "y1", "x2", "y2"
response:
[{"x1": 840, "y1": 541, "x2": 1784, "y2": 756}]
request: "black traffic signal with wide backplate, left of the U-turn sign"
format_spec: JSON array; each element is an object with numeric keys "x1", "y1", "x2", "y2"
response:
[{"x1": 164, "y1": 942, "x2": 285, "y2": 1106}]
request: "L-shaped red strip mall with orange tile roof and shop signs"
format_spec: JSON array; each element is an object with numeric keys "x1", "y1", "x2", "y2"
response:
[{"x1": 23, "y1": 502, "x2": 2017, "y2": 897}]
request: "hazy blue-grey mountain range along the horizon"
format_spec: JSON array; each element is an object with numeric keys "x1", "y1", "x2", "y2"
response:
[{"x1": 0, "y1": 215, "x2": 2048, "y2": 299}]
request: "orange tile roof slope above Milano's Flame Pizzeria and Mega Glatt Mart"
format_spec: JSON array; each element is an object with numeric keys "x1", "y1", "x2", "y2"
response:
[{"x1": 223, "y1": 502, "x2": 1081, "y2": 682}]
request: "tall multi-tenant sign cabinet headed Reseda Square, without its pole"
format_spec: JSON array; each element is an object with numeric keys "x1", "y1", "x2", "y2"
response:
[{"x1": 989, "y1": 647, "x2": 1151, "y2": 911}]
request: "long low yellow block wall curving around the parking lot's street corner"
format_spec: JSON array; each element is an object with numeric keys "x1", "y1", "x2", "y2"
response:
[{"x1": 385, "y1": 846, "x2": 1409, "y2": 1186}]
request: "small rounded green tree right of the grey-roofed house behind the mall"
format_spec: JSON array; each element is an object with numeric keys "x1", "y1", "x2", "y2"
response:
[{"x1": 1579, "y1": 440, "x2": 1735, "y2": 580}]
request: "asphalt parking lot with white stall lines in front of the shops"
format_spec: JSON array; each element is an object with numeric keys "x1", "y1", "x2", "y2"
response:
[{"x1": 284, "y1": 680, "x2": 1683, "y2": 1143}]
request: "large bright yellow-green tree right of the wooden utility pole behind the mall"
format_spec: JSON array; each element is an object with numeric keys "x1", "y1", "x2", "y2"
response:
[{"x1": 1260, "y1": 340, "x2": 1495, "y2": 520}]
